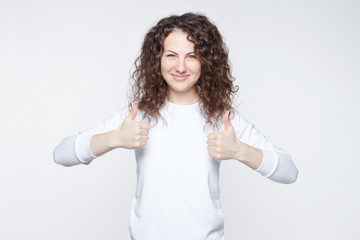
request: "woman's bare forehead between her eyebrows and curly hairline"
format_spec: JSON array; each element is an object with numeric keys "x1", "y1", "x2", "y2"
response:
[{"x1": 164, "y1": 29, "x2": 194, "y2": 52}]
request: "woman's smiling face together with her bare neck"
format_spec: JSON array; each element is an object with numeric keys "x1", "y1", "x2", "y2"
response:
[{"x1": 161, "y1": 30, "x2": 201, "y2": 104}]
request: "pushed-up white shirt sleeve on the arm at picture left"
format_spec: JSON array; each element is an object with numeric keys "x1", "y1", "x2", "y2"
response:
[{"x1": 53, "y1": 107, "x2": 128, "y2": 167}]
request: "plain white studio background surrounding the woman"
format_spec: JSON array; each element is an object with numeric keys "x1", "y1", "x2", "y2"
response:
[{"x1": 0, "y1": 0, "x2": 360, "y2": 240}]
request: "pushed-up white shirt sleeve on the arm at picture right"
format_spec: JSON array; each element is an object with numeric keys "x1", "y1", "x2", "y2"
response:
[{"x1": 231, "y1": 110, "x2": 298, "y2": 184}]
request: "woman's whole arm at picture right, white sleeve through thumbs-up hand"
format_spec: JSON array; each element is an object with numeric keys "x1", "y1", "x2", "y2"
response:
[{"x1": 207, "y1": 110, "x2": 298, "y2": 183}]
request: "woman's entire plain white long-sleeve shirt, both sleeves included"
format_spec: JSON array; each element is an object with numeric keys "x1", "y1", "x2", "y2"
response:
[{"x1": 54, "y1": 101, "x2": 298, "y2": 240}]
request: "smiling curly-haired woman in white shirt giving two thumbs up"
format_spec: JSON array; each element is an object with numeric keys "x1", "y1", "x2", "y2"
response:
[{"x1": 54, "y1": 13, "x2": 297, "y2": 240}]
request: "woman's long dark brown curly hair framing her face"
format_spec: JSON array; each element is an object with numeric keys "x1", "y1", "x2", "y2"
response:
[{"x1": 130, "y1": 13, "x2": 239, "y2": 124}]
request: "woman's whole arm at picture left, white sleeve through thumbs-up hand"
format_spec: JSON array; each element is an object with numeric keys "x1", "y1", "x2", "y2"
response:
[{"x1": 53, "y1": 104, "x2": 150, "y2": 166}]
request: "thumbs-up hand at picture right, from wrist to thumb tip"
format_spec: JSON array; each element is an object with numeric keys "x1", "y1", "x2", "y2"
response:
[{"x1": 207, "y1": 111, "x2": 246, "y2": 160}]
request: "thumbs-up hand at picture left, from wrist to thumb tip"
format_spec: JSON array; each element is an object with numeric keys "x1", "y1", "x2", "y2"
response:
[{"x1": 116, "y1": 102, "x2": 150, "y2": 149}]
